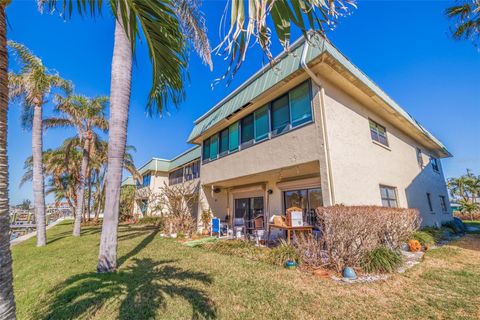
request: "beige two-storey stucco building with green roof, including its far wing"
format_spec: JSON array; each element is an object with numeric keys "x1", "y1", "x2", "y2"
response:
[{"x1": 124, "y1": 34, "x2": 452, "y2": 230}]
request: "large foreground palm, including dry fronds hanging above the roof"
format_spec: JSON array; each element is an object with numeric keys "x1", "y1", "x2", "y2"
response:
[{"x1": 39, "y1": 0, "x2": 355, "y2": 272}]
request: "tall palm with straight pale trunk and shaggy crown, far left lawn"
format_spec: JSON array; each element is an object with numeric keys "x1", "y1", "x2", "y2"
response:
[{"x1": 8, "y1": 41, "x2": 72, "y2": 246}]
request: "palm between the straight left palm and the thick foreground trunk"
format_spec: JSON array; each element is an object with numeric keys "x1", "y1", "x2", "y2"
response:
[{"x1": 43, "y1": 95, "x2": 108, "y2": 237}]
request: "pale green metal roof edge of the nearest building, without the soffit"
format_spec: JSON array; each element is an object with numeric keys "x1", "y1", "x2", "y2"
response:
[{"x1": 188, "y1": 35, "x2": 451, "y2": 156}]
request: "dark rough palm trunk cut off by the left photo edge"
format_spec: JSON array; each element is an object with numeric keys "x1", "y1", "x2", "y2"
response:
[{"x1": 0, "y1": 5, "x2": 15, "y2": 320}]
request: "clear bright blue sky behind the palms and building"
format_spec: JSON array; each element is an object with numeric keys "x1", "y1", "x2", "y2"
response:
[{"x1": 7, "y1": 0, "x2": 480, "y2": 204}]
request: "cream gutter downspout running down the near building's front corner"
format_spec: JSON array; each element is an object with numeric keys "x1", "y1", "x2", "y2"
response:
[{"x1": 300, "y1": 35, "x2": 335, "y2": 205}]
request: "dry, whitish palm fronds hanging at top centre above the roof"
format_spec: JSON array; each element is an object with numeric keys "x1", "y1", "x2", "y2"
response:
[{"x1": 214, "y1": 0, "x2": 356, "y2": 79}]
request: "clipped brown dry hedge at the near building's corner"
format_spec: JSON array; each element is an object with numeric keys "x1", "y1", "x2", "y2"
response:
[{"x1": 317, "y1": 206, "x2": 420, "y2": 272}]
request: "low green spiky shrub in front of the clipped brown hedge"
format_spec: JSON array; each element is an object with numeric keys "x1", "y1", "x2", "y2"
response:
[{"x1": 360, "y1": 246, "x2": 402, "y2": 273}]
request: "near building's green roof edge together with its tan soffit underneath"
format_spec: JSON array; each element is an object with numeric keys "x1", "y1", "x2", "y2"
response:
[{"x1": 188, "y1": 35, "x2": 452, "y2": 158}]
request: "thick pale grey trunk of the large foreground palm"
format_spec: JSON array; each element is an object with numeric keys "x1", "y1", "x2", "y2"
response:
[{"x1": 97, "y1": 16, "x2": 132, "y2": 272}]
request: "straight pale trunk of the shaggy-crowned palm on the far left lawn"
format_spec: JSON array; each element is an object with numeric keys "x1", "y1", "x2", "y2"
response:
[{"x1": 32, "y1": 100, "x2": 47, "y2": 247}]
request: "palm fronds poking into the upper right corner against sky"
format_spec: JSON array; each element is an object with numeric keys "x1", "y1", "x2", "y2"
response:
[{"x1": 445, "y1": 0, "x2": 480, "y2": 45}]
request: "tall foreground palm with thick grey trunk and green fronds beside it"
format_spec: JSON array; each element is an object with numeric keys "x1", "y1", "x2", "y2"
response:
[{"x1": 39, "y1": 0, "x2": 211, "y2": 272}]
